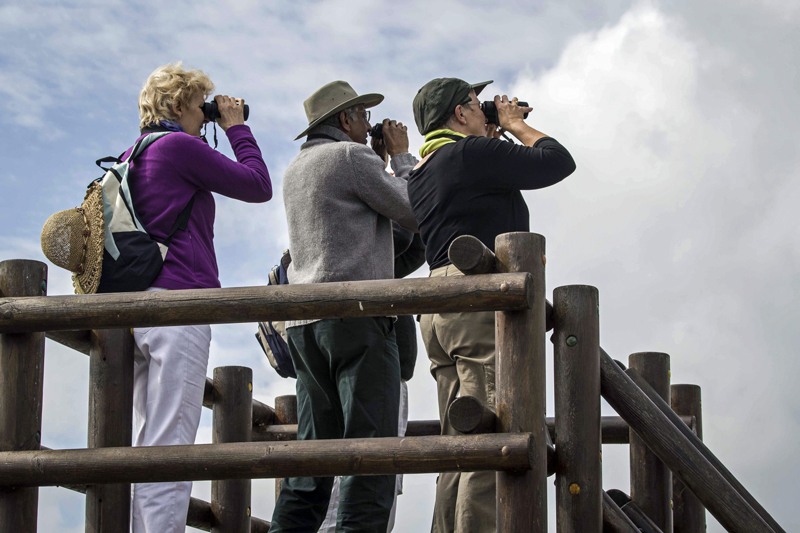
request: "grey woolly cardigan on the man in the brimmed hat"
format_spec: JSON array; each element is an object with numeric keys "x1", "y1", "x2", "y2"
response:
[{"x1": 283, "y1": 126, "x2": 418, "y2": 327}]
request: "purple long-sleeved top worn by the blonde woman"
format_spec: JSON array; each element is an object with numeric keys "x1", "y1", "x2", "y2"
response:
[{"x1": 122, "y1": 125, "x2": 272, "y2": 289}]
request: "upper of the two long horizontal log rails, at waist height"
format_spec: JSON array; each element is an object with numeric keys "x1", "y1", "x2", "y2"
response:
[{"x1": 0, "y1": 273, "x2": 533, "y2": 333}]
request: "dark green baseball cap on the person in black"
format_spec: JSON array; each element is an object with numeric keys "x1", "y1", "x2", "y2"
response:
[{"x1": 414, "y1": 78, "x2": 494, "y2": 135}]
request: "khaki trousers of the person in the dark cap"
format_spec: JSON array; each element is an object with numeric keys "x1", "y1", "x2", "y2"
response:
[{"x1": 420, "y1": 265, "x2": 497, "y2": 533}]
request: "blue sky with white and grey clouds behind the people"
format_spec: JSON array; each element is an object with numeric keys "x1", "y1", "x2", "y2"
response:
[{"x1": 0, "y1": 0, "x2": 800, "y2": 533}]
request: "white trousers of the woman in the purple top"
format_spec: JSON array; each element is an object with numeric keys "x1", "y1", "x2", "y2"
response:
[{"x1": 131, "y1": 318, "x2": 211, "y2": 533}]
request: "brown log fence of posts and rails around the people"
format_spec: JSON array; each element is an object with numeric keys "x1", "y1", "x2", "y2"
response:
[{"x1": 0, "y1": 233, "x2": 784, "y2": 533}]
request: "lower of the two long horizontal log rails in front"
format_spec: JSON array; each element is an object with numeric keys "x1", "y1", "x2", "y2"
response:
[{"x1": 0, "y1": 433, "x2": 533, "y2": 487}]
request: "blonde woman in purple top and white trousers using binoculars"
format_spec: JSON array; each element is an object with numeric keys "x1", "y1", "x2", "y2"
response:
[{"x1": 129, "y1": 63, "x2": 272, "y2": 533}]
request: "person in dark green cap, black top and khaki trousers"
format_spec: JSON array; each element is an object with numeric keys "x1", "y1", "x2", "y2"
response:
[{"x1": 408, "y1": 78, "x2": 575, "y2": 533}]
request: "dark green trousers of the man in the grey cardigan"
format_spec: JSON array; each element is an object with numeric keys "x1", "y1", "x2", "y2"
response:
[{"x1": 270, "y1": 317, "x2": 400, "y2": 533}]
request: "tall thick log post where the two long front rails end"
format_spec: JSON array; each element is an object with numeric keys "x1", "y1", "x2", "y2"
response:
[{"x1": 495, "y1": 232, "x2": 547, "y2": 533}]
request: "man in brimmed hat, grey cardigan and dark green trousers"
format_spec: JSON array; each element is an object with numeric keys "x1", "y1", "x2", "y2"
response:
[{"x1": 270, "y1": 81, "x2": 417, "y2": 533}]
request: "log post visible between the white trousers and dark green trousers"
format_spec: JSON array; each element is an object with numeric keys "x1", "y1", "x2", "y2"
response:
[{"x1": 211, "y1": 366, "x2": 253, "y2": 533}]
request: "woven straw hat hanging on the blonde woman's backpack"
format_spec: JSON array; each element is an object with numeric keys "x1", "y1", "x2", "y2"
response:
[{"x1": 42, "y1": 182, "x2": 105, "y2": 294}]
